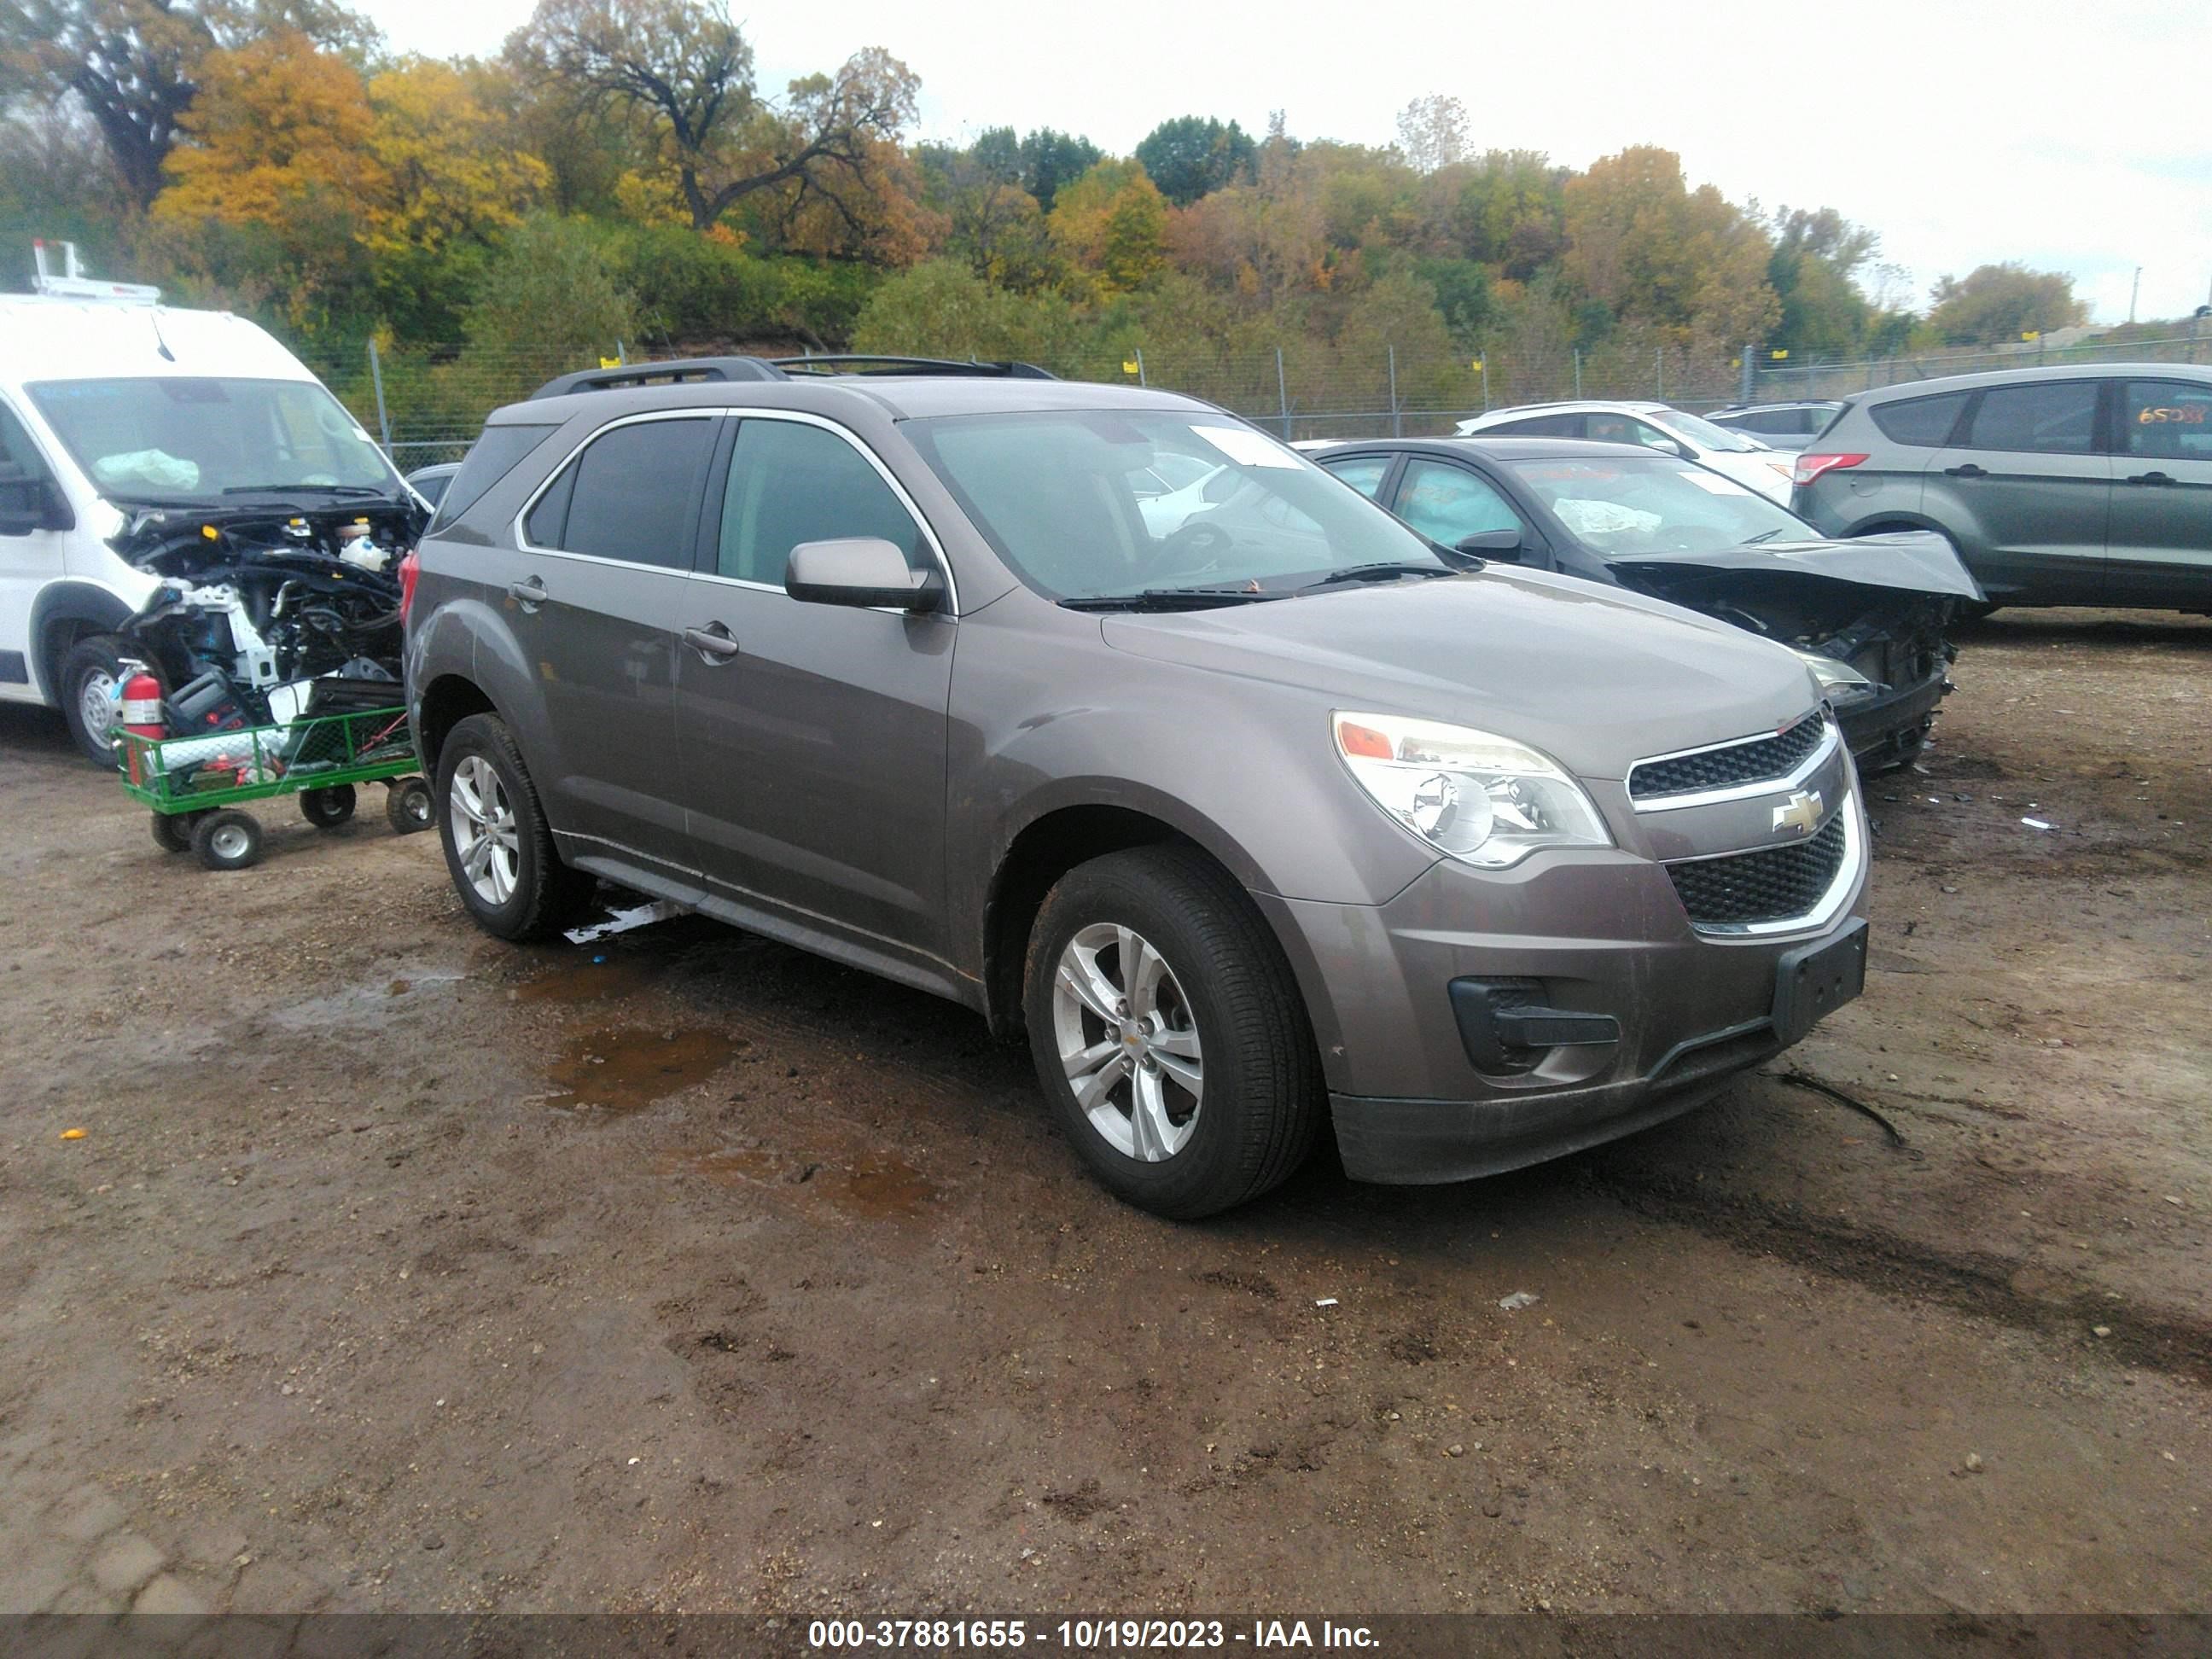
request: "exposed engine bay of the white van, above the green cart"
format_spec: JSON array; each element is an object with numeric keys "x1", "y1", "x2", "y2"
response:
[{"x1": 113, "y1": 498, "x2": 425, "y2": 732}]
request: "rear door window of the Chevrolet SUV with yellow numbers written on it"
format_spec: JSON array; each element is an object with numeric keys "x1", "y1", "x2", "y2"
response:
[{"x1": 524, "y1": 416, "x2": 714, "y2": 571}]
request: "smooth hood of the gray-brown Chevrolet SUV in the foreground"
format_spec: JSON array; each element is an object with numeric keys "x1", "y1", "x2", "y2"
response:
[{"x1": 1102, "y1": 567, "x2": 1819, "y2": 778}]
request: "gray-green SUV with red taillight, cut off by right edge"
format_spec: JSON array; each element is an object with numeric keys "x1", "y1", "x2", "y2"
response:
[{"x1": 1792, "y1": 363, "x2": 2212, "y2": 610}]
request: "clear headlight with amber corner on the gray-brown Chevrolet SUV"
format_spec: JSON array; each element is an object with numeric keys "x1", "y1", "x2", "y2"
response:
[{"x1": 1334, "y1": 714, "x2": 1613, "y2": 870}]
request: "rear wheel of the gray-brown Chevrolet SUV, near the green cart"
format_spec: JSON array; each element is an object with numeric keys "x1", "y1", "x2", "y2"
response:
[{"x1": 436, "y1": 714, "x2": 597, "y2": 940}]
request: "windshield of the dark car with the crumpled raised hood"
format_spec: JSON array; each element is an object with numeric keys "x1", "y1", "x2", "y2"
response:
[{"x1": 1505, "y1": 453, "x2": 1820, "y2": 557}]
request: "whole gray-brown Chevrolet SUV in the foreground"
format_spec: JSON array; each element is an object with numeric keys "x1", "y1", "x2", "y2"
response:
[{"x1": 407, "y1": 358, "x2": 1867, "y2": 1217}]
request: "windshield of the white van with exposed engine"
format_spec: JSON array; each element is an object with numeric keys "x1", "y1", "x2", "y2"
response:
[{"x1": 26, "y1": 376, "x2": 400, "y2": 502}]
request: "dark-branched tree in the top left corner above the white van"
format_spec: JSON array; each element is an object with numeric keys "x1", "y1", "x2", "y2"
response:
[{"x1": 0, "y1": 0, "x2": 376, "y2": 208}]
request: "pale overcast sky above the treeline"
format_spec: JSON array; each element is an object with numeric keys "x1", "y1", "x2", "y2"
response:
[{"x1": 363, "y1": 0, "x2": 2212, "y2": 323}]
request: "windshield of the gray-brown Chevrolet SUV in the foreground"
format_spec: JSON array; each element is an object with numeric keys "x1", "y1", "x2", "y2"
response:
[{"x1": 907, "y1": 410, "x2": 1458, "y2": 599}]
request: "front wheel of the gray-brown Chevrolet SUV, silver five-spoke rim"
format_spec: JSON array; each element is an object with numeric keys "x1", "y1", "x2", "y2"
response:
[{"x1": 1022, "y1": 847, "x2": 1323, "y2": 1221}]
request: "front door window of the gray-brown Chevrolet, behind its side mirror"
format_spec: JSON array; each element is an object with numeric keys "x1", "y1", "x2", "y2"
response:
[{"x1": 714, "y1": 420, "x2": 929, "y2": 588}]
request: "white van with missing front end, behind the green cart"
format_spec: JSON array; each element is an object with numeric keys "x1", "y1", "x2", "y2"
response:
[{"x1": 0, "y1": 281, "x2": 422, "y2": 765}]
